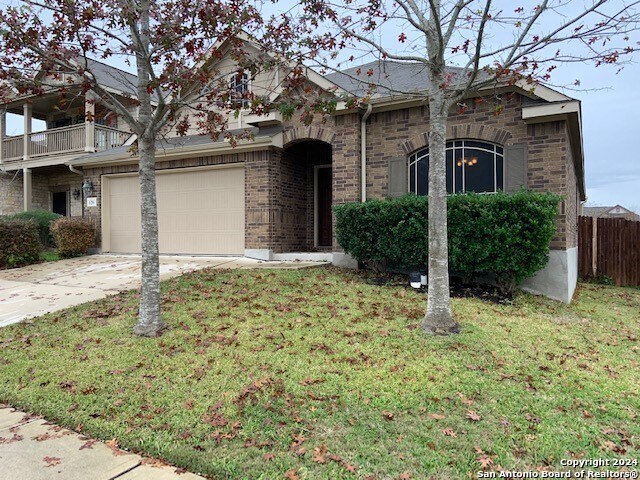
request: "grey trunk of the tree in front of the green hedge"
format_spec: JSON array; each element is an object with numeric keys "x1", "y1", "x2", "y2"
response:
[{"x1": 422, "y1": 91, "x2": 460, "y2": 335}]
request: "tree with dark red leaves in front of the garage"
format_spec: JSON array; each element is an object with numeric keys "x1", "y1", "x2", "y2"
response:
[{"x1": 0, "y1": 0, "x2": 261, "y2": 336}]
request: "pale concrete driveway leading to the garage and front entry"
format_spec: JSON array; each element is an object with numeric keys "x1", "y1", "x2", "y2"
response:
[{"x1": 0, "y1": 254, "x2": 322, "y2": 327}]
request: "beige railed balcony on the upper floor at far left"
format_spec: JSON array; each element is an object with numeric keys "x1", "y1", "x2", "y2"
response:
[{"x1": 0, "y1": 123, "x2": 131, "y2": 164}]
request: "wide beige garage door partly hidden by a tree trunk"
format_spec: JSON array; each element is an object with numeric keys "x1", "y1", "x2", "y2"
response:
[{"x1": 105, "y1": 167, "x2": 244, "y2": 255}]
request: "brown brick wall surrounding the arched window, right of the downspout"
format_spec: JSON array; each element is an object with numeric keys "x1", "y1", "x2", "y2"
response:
[{"x1": 364, "y1": 95, "x2": 579, "y2": 250}]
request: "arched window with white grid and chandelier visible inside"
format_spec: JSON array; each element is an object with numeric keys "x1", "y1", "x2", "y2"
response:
[{"x1": 408, "y1": 140, "x2": 504, "y2": 195}]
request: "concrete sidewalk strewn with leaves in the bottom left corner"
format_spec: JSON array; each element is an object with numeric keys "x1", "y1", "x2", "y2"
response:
[{"x1": 0, "y1": 406, "x2": 204, "y2": 480}]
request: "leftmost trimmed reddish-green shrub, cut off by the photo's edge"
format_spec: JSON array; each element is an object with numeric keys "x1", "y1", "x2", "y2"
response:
[{"x1": 0, "y1": 219, "x2": 42, "y2": 268}]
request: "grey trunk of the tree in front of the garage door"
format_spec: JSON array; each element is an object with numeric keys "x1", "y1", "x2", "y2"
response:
[{"x1": 133, "y1": 136, "x2": 166, "y2": 337}]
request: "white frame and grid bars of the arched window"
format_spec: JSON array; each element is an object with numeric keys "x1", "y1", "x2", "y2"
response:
[{"x1": 407, "y1": 138, "x2": 505, "y2": 195}]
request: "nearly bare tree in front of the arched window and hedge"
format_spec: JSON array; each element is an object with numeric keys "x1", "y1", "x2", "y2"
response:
[{"x1": 274, "y1": 0, "x2": 640, "y2": 334}]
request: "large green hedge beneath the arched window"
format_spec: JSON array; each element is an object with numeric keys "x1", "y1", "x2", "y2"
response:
[{"x1": 334, "y1": 191, "x2": 560, "y2": 290}]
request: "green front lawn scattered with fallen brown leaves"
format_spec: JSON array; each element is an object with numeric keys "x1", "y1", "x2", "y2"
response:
[{"x1": 0, "y1": 269, "x2": 640, "y2": 479}]
